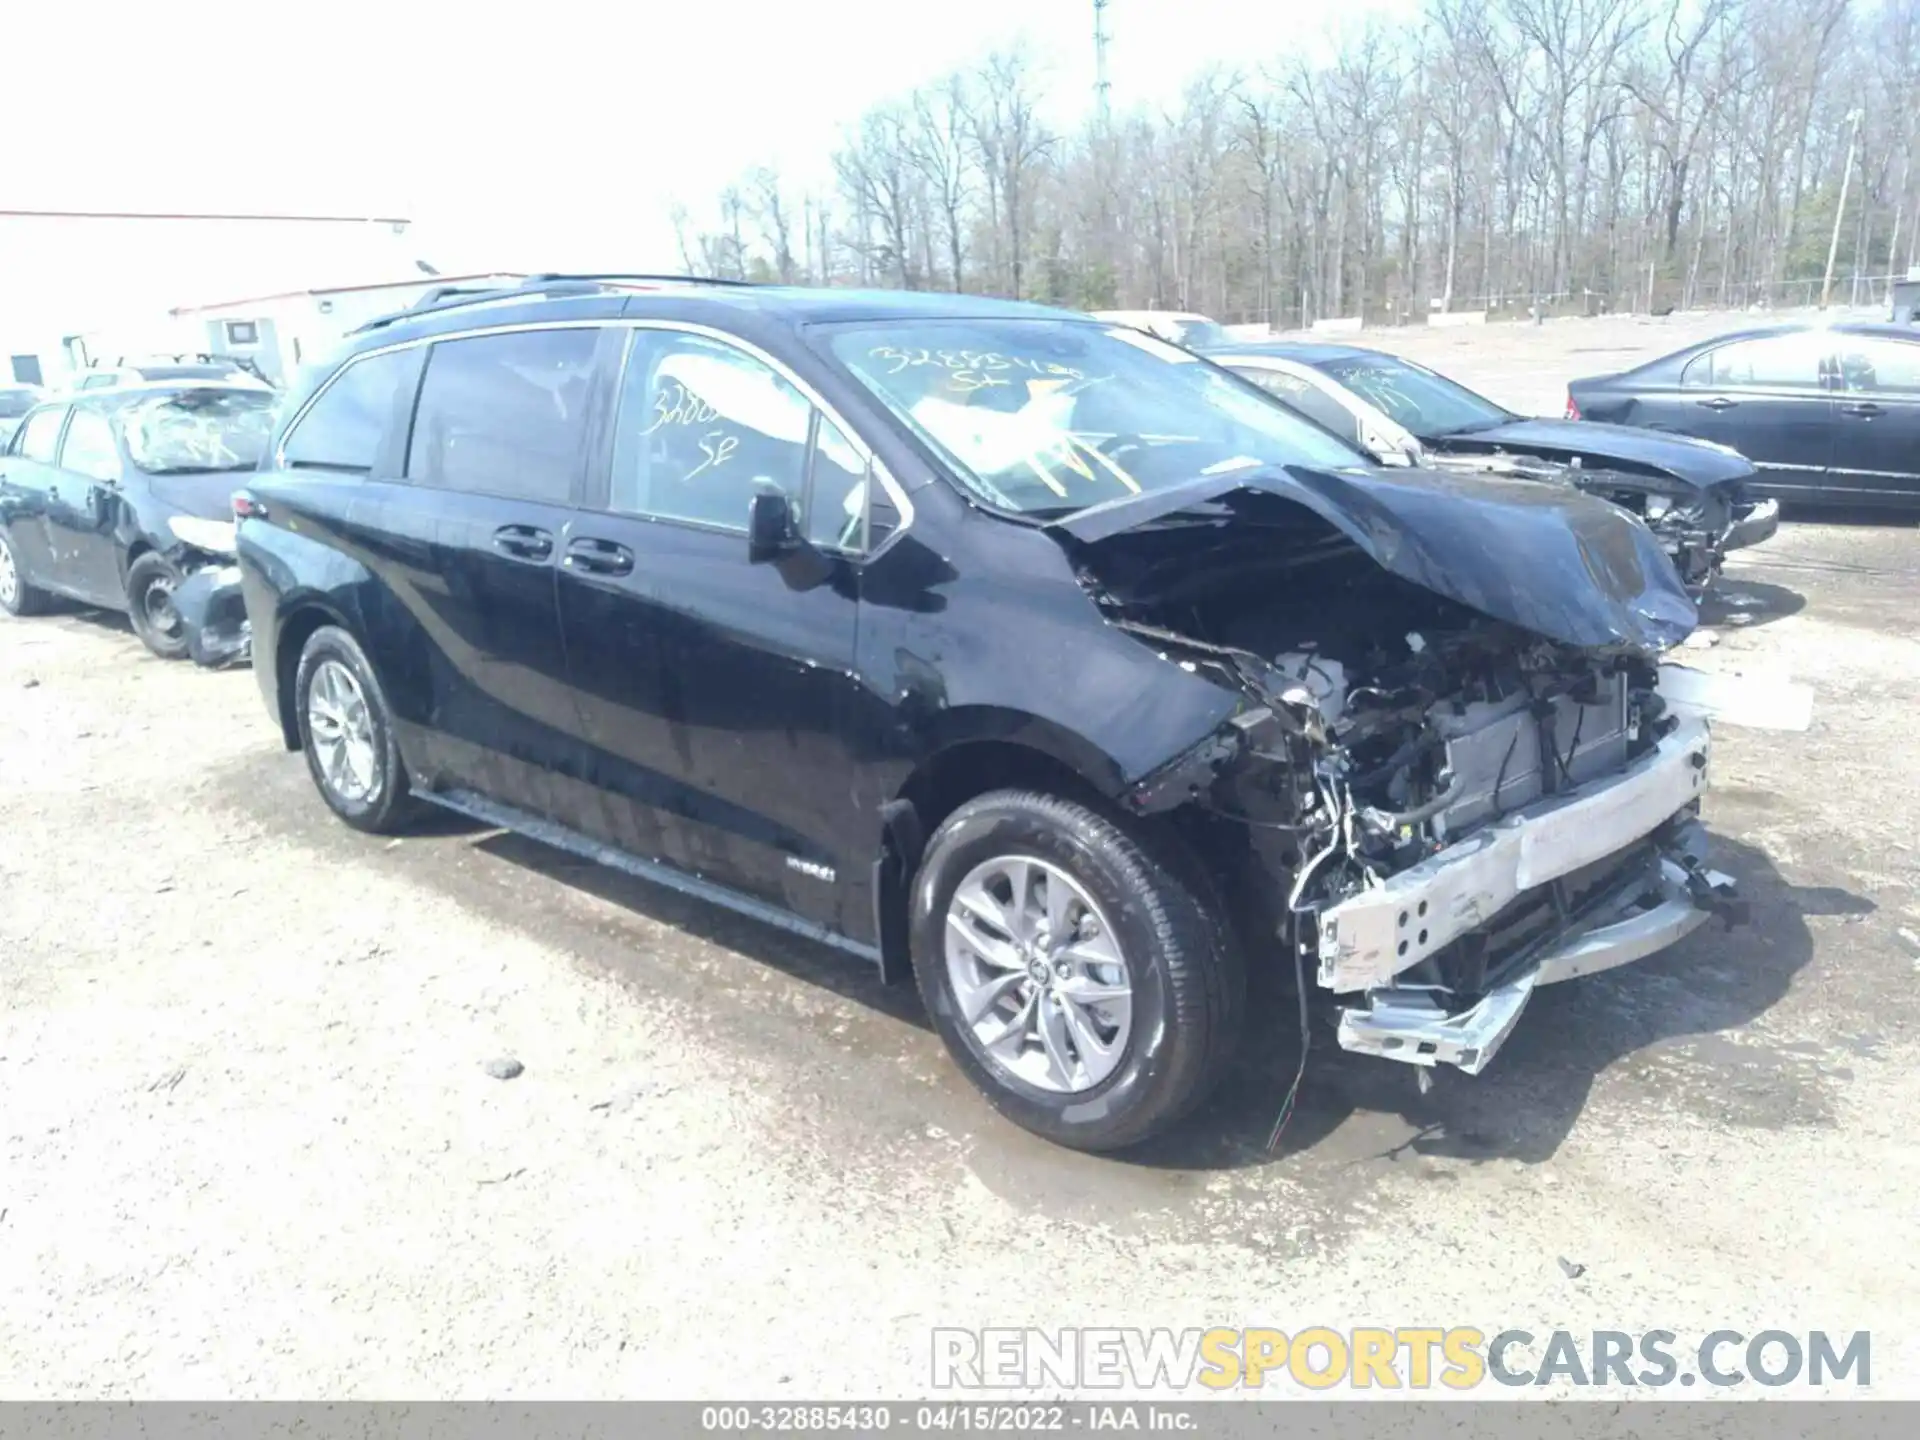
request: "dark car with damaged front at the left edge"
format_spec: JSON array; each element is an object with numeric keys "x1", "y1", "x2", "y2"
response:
[{"x1": 0, "y1": 384, "x2": 276, "y2": 659}]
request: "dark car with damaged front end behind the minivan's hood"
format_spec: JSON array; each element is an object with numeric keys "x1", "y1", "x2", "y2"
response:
[{"x1": 1206, "y1": 342, "x2": 1780, "y2": 595}]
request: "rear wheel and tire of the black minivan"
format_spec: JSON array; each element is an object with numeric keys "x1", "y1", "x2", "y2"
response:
[{"x1": 294, "y1": 626, "x2": 419, "y2": 835}]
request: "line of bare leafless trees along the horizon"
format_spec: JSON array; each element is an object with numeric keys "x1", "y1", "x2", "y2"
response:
[{"x1": 672, "y1": 0, "x2": 1920, "y2": 326}]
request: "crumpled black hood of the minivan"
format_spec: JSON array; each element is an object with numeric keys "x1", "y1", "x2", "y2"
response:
[{"x1": 1046, "y1": 467, "x2": 1697, "y2": 653}]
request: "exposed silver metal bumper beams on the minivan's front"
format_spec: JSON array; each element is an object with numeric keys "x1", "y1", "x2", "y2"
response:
[{"x1": 1319, "y1": 714, "x2": 1734, "y2": 1075}]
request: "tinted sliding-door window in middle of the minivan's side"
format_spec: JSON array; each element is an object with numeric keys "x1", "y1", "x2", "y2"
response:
[{"x1": 407, "y1": 328, "x2": 599, "y2": 505}]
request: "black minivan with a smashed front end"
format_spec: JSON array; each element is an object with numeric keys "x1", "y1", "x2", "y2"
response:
[{"x1": 234, "y1": 276, "x2": 1730, "y2": 1148}]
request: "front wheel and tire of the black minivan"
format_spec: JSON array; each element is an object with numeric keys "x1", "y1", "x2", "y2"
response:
[{"x1": 910, "y1": 791, "x2": 1246, "y2": 1150}]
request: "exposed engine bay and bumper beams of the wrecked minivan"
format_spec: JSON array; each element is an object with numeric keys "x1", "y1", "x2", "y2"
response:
[{"x1": 1081, "y1": 506, "x2": 1732, "y2": 1073}]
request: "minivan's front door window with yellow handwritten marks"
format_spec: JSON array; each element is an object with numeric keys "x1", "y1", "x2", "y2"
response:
[{"x1": 609, "y1": 330, "x2": 817, "y2": 534}]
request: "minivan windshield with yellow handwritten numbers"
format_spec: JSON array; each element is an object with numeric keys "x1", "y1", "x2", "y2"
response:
[{"x1": 831, "y1": 321, "x2": 1369, "y2": 516}]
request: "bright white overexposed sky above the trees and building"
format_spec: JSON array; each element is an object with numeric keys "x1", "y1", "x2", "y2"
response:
[{"x1": 0, "y1": 0, "x2": 1415, "y2": 330}]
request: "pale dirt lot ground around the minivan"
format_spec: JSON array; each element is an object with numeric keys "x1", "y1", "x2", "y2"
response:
[{"x1": 0, "y1": 319, "x2": 1920, "y2": 1398}]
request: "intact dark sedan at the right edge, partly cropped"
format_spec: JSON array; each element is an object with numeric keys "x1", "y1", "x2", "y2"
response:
[{"x1": 1567, "y1": 324, "x2": 1920, "y2": 507}]
